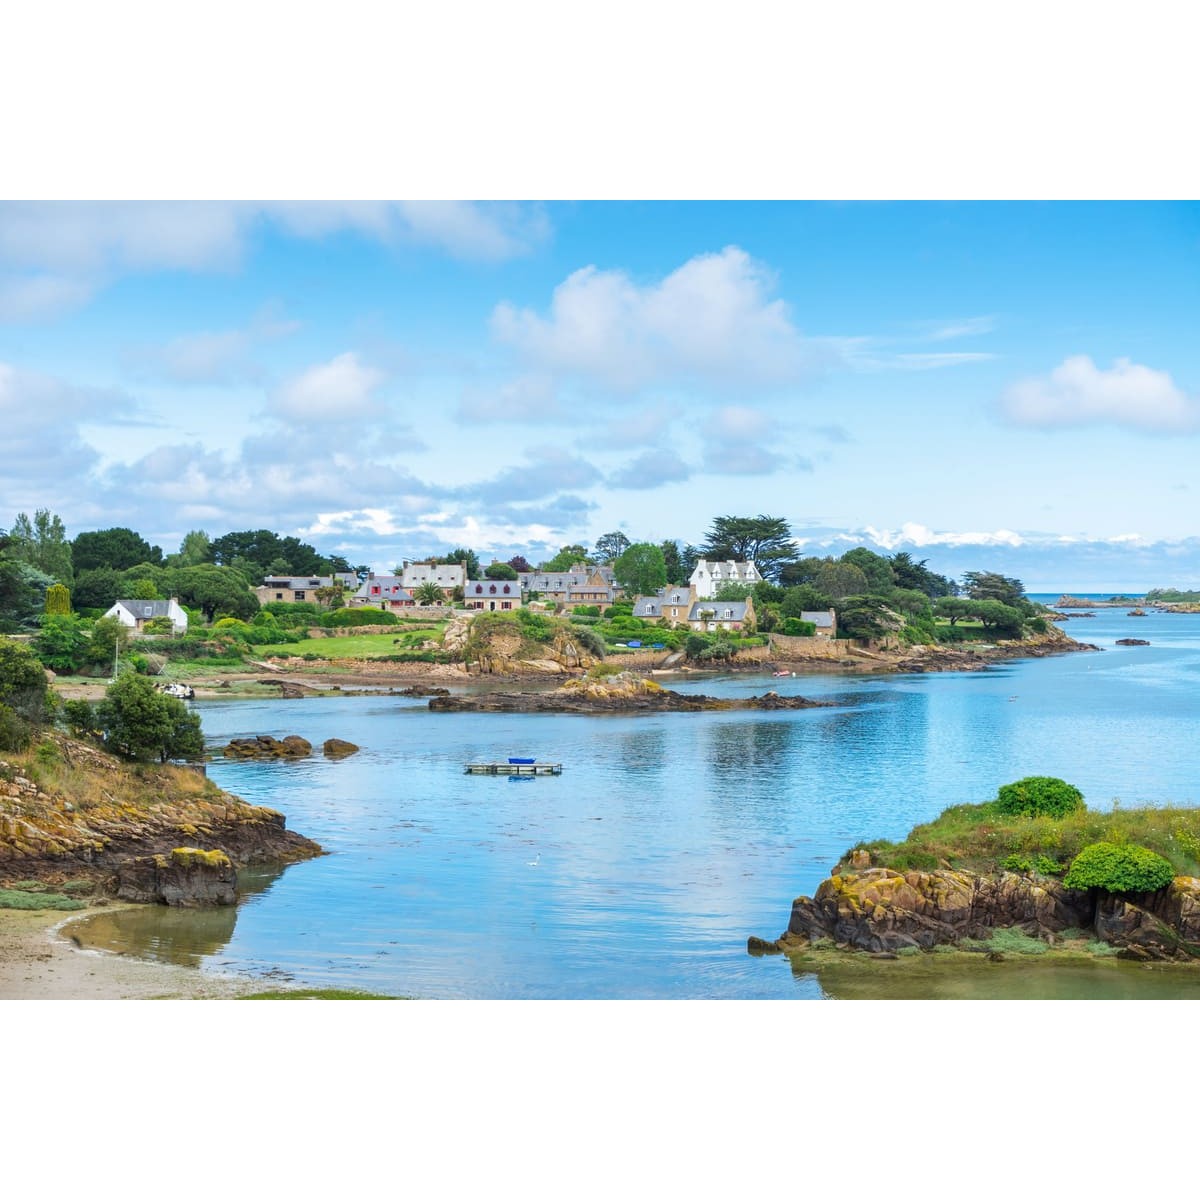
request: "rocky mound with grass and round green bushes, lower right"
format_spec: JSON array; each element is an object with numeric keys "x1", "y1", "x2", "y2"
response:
[{"x1": 748, "y1": 776, "x2": 1200, "y2": 964}]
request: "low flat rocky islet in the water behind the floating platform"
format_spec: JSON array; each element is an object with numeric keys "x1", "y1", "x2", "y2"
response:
[{"x1": 430, "y1": 671, "x2": 828, "y2": 713}]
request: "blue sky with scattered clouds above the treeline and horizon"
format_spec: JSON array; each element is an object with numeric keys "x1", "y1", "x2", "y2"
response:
[{"x1": 0, "y1": 202, "x2": 1200, "y2": 590}]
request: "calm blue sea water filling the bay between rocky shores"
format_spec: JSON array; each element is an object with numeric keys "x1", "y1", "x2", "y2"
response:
[{"x1": 73, "y1": 608, "x2": 1200, "y2": 1000}]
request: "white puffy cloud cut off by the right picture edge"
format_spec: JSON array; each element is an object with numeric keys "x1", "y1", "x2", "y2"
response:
[{"x1": 1001, "y1": 354, "x2": 1200, "y2": 433}]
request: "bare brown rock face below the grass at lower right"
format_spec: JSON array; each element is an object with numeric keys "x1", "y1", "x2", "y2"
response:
[{"x1": 756, "y1": 868, "x2": 1200, "y2": 959}]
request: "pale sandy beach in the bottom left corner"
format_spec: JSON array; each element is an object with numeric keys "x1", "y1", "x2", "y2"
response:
[{"x1": 0, "y1": 911, "x2": 270, "y2": 1000}]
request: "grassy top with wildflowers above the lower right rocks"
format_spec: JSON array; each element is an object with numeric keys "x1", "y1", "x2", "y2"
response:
[{"x1": 842, "y1": 802, "x2": 1200, "y2": 875}]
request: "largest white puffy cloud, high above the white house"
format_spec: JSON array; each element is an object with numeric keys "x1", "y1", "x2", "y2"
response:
[{"x1": 492, "y1": 246, "x2": 810, "y2": 390}]
